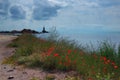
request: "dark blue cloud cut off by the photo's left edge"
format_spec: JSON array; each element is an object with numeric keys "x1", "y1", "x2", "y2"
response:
[{"x1": 0, "y1": 0, "x2": 10, "y2": 17}]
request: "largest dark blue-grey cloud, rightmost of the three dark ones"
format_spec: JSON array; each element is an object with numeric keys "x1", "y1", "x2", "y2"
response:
[{"x1": 32, "y1": 0, "x2": 61, "y2": 20}]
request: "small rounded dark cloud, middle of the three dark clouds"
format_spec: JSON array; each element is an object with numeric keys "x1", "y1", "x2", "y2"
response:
[{"x1": 10, "y1": 5, "x2": 26, "y2": 19}]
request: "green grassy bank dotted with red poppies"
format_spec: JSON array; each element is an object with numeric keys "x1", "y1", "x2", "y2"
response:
[{"x1": 4, "y1": 34, "x2": 120, "y2": 80}]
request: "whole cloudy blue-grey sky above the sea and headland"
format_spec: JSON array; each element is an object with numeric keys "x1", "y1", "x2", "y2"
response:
[{"x1": 0, "y1": 0, "x2": 120, "y2": 31}]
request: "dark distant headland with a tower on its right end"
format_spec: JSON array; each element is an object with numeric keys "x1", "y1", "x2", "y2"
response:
[{"x1": 0, "y1": 27, "x2": 49, "y2": 34}]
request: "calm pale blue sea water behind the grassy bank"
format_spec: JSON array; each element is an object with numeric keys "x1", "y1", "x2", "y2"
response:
[{"x1": 36, "y1": 31, "x2": 120, "y2": 48}]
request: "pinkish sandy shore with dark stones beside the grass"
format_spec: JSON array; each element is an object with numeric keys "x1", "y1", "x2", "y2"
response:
[{"x1": 0, "y1": 35, "x2": 66, "y2": 80}]
